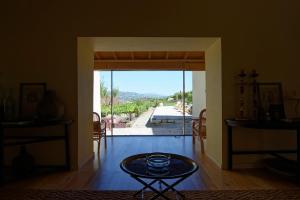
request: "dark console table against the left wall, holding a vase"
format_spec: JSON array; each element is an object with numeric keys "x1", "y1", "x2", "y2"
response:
[{"x1": 0, "y1": 120, "x2": 73, "y2": 183}]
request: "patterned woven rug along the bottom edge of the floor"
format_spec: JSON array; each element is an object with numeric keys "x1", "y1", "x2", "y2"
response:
[{"x1": 0, "y1": 190, "x2": 300, "y2": 200}]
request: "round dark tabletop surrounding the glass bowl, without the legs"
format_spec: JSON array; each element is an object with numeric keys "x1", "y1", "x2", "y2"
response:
[{"x1": 120, "y1": 152, "x2": 198, "y2": 179}]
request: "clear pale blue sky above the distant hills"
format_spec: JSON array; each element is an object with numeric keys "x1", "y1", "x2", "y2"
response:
[{"x1": 100, "y1": 71, "x2": 192, "y2": 96}]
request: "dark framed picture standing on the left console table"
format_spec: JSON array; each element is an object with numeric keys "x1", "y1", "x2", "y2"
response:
[{"x1": 19, "y1": 83, "x2": 46, "y2": 120}]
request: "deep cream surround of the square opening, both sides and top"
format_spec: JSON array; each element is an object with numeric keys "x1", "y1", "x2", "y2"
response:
[{"x1": 78, "y1": 37, "x2": 223, "y2": 167}]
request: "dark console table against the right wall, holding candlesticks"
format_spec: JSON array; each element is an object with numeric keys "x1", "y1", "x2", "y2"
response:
[{"x1": 225, "y1": 119, "x2": 300, "y2": 170}]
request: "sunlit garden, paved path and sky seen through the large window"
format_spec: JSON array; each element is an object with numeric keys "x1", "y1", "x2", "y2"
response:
[{"x1": 95, "y1": 71, "x2": 193, "y2": 135}]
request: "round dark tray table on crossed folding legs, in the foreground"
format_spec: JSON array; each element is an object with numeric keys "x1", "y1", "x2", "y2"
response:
[{"x1": 120, "y1": 152, "x2": 199, "y2": 199}]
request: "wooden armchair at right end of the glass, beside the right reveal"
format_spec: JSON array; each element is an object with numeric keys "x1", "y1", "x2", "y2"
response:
[{"x1": 192, "y1": 109, "x2": 206, "y2": 153}]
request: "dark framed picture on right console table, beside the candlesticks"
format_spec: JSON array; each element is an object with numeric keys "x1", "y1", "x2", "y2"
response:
[{"x1": 257, "y1": 82, "x2": 285, "y2": 120}]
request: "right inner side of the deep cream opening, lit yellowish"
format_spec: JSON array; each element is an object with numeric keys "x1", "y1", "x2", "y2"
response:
[{"x1": 205, "y1": 39, "x2": 223, "y2": 167}]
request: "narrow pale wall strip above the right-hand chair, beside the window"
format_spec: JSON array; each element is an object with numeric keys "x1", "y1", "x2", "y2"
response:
[{"x1": 192, "y1": 71, "x2": 206, "y2": 117}]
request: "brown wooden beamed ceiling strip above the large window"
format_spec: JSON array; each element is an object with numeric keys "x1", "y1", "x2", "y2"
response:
[{"x1": 94, "y1": 51, "x2": 205, "y2": 71}]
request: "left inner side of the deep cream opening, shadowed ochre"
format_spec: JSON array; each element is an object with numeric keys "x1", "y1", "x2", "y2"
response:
[{"x1": 77, "y1": 37, "x2": 94, "y2": 168}]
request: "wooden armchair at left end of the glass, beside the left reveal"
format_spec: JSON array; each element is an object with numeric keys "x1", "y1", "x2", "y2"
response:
[{"x1": 93, "y1": 112, "x2": 106, "y2": 155}]
